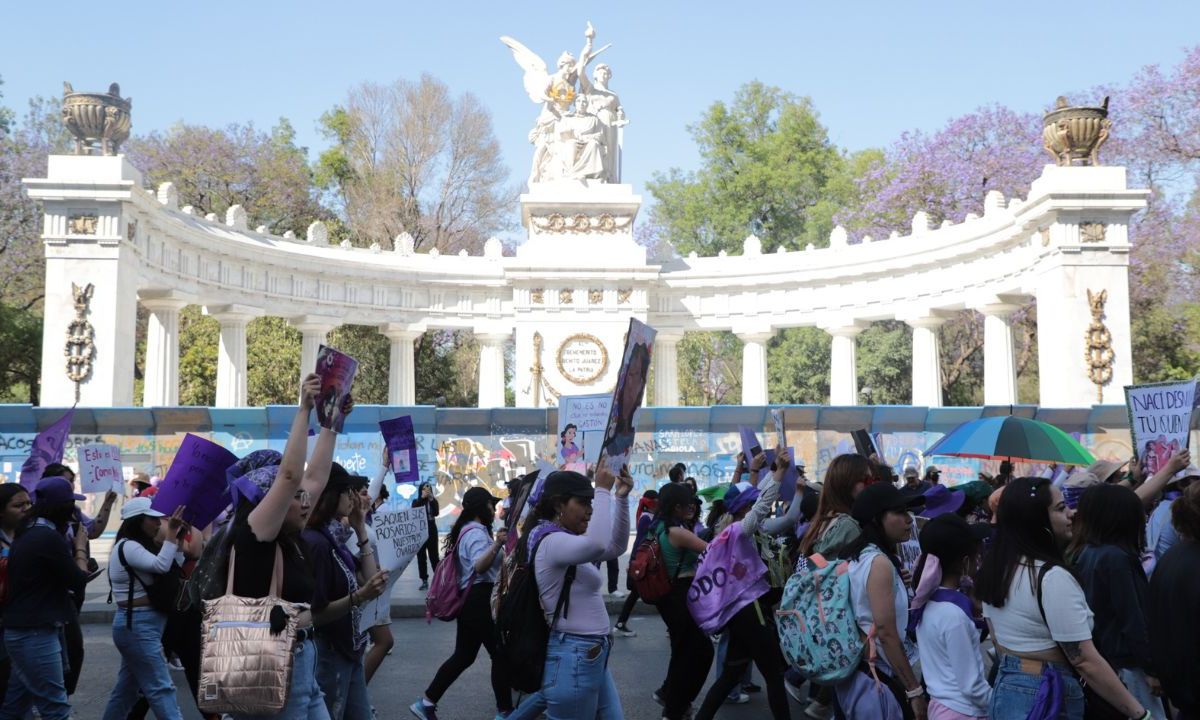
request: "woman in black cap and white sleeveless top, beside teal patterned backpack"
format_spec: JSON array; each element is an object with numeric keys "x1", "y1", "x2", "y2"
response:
[{"x1": 836, "y1": 482, "x2": 925, "y2": 720}]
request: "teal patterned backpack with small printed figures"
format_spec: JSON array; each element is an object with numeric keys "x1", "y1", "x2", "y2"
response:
[{"x1": 775, "y1": 554, "x2": 870, "y2": 685}]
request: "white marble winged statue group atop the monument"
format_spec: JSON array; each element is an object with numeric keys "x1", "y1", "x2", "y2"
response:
[{"x1": 500, "y1": 23, "x2": 626, "y2": 185}]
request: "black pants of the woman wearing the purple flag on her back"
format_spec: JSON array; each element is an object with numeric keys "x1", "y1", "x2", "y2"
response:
[{"x1": 696, "y1": 601, "x2": 791, "y2": 720}]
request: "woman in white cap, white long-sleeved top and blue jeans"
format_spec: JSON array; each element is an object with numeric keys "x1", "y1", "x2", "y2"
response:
[{"x1": 104, "y1": 498, "x2": 188, "y2": 720}]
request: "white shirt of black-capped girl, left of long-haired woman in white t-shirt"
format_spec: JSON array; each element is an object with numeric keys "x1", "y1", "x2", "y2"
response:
[{"x1": 917, "y1": 595, "x2": 991, "y2": 718}]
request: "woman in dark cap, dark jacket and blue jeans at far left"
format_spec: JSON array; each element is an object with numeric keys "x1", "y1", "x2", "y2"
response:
[{"x1": 0, "y1": 478, "x2": 88, "y2": 720}]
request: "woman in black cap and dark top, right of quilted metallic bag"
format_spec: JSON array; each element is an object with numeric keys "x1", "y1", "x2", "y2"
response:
[{"x1": 301, "y1": 462, "x2": 388, "y2": 720}]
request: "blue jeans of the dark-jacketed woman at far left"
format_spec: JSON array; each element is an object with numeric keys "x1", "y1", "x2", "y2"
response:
[{"x1": 0, "y1": 625, "x2": 71, "y2": 720}]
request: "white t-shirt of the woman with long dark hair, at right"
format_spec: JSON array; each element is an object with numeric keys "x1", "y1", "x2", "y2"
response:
[{"x1": 983, "y1": 560, "x2": 1093, "y2": 653}]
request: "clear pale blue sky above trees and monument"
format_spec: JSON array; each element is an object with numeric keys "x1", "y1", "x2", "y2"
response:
[{"x1": 0, "y1": 0, "x2": 1200, "y2": 207}]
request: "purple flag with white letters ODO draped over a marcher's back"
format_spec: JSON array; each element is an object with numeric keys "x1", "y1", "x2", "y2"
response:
[{"x1": 688, "y1": 522, "x2": 770, "y2": 635}]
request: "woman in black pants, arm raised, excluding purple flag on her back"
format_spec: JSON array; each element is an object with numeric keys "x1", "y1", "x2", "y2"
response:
[{"x1": 696, "y1": 448, "x2": 804, "y2": 720}]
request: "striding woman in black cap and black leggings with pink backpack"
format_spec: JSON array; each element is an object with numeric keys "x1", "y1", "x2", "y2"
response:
[{"x1": 408, "y1": 487, "x2": 512, "y2": 720}]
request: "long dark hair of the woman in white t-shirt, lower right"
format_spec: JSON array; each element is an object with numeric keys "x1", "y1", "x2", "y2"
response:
[{"x1": 976, "y1": 478, "x2": 1064, "y2": 607}]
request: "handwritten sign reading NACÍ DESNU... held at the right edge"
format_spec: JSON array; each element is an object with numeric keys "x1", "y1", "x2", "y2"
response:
[{"x1": 1126, "y1": 380, "x2": 1196, "y2": 474}]
